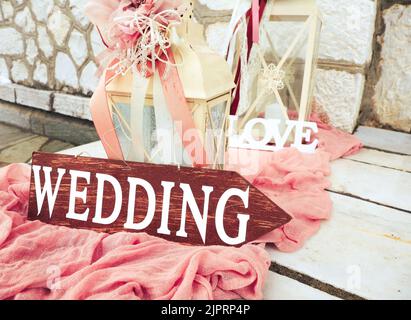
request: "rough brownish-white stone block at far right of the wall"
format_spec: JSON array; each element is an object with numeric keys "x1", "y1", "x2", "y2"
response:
[{"x1": 360, "y1": 0, "x2": 411, "y2": 132}]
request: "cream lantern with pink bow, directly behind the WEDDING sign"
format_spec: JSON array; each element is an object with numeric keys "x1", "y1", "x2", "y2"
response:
[{"x1": 106, "y1": 10, "x2": 235, "y2": 168}]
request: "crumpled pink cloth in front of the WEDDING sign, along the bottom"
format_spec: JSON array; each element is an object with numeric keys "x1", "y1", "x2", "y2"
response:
[{"x1": 0, "y1": 164, "x2": 270, "y2": 299}]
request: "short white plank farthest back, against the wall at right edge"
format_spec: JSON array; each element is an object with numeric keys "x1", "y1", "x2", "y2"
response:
[{"x1": 355, "y1": 127, "x2": 411, "y2": 155}]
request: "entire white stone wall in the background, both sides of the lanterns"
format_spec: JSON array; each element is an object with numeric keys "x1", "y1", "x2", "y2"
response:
[{"x1": 0, "y1": 0, "x2": 411, "y2": 131}]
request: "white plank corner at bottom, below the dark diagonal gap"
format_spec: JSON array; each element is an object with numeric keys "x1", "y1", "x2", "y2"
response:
[{"x1": 264, "y1": 271, "x2": 340, "y2": 300}]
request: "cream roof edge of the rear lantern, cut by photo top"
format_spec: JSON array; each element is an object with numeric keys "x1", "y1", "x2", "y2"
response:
[{"x1": 271, "y1": 0, "x2": 319, "y2": 16}]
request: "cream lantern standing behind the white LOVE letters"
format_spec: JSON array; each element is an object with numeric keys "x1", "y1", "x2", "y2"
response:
[{"x1": 240, "y1": 0, "x2": 321, "y2": 128}]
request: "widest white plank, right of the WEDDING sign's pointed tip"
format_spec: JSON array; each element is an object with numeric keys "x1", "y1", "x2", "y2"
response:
[{"x1": 269, "y1": 194, "x2": 411, "y2": 299}]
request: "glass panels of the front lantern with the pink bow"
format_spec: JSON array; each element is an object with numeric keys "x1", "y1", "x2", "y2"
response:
[{"x1": 109, "y1": 94, "x2": 230, "y2": 168}]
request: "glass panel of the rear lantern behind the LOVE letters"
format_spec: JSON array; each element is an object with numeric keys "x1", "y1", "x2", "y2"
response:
[{"x1": 258, "y1": 15, "x2": 320, "y2": 120}]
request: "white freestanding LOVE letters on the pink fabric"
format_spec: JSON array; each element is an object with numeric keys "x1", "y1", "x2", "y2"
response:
[{"x1": 228, "y1": 116, "x2": 318, "y2": 153}]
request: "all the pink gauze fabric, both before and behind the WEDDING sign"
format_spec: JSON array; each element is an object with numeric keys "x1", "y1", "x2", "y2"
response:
[{"x1": 0, "y1": 117, "x2": 361, "y2": 299}]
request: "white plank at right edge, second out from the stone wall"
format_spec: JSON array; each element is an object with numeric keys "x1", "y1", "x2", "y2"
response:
[{"x1": 330, "y1": 159, "x2": 411, "y2": 211}]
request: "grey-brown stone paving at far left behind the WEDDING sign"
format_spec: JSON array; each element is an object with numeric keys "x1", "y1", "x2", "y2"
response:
[{"x1": 0, "y1": 123, "x2": 74, "y2": 167}]
